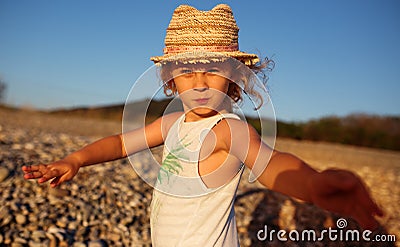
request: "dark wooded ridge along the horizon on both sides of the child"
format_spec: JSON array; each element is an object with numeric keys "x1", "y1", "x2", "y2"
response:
[{"x1": 43, "y1": 100, "x2": 400, "y2": 150}]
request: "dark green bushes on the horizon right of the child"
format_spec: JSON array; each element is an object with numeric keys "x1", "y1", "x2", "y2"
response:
[{"x1": 277, "y1": 114, "x2": 400, "y2": 150}]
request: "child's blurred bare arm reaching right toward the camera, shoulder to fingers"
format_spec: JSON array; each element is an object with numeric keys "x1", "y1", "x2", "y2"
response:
[{"x1": 228, "y1": 121, "x2": 383, "y2": 229}]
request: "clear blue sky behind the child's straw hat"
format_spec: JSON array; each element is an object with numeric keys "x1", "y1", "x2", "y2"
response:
[{"x1": 0, "y1": 0, "x2": 400, "y2": 121}]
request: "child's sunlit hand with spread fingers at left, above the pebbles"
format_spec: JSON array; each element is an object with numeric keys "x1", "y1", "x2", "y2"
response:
[{"x1": 22, "y1": 160, "x2": 79, "y2": 188}]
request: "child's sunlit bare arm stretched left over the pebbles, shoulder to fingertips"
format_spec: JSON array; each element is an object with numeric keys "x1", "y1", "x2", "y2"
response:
[{"x1": 22, "y1": 114, "x2": 178, "y2": 187}]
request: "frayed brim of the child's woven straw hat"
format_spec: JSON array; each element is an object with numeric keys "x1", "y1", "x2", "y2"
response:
[{"x1": 150, "y1": 51, "x2": 260, "y2": 65}]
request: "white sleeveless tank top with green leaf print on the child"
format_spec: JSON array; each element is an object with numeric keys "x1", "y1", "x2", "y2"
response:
[{"x1": 150, "y1": 113, "x2": 243, "y2": 247}]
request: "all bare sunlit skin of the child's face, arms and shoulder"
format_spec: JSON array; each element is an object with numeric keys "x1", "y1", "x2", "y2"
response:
[{"x1": 22, "y1": 61, "x2": 383, "y2": 229}]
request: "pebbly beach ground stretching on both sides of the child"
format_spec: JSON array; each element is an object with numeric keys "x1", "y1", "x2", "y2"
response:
[{"x1": 0, "y1": 108, "x2": 400, "y2": 246}]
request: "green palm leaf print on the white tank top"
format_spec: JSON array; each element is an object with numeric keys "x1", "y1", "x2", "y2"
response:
[{"x1": 158, "y1": 135, "x2": 191, "y2": 183}]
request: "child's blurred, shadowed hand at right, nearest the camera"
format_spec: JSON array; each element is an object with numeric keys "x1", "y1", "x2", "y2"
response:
[{"x1": 309, "y1": 169, "x2": 383, "y2": 229}]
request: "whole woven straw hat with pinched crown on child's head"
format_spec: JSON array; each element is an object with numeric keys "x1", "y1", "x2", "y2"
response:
[{"x1": 150, "y1": 4, "x2": 259, "y2": 65}]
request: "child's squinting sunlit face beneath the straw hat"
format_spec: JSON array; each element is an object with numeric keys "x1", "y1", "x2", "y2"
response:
[{"x1": 172, "y1": 63, "x2": 233, "y2": 121}]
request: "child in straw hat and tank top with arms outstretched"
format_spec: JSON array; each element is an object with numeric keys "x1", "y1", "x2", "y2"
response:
[{"x1": 22, "y1": 4, "x2": 382, "y2": 246}]
